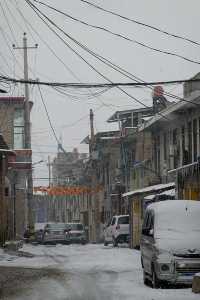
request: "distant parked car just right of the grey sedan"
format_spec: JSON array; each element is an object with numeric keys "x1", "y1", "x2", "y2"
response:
[{"x1": 66, "y1": 223, "x2": 87, "y2": 244}]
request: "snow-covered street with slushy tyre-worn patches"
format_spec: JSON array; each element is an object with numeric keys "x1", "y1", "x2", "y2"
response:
[{"x1": 0, "y1": 244, "x2": 199, "y2": 300}]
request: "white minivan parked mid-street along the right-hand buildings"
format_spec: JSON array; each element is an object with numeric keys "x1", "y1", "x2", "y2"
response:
[{"x1": 104, "y1": 215, "x2": 129, "y2": 247}]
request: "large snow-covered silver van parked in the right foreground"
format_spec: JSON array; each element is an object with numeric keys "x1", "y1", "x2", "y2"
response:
[{"x1": 141, "y1": 200, "x2": 200, "y2": 288}]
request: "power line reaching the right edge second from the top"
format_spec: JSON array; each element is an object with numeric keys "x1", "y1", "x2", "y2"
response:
[{"x1": 34, "y1": 0, "x2": 200, "y2": 65}]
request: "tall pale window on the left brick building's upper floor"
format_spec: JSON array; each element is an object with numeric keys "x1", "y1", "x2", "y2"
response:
[{"x1": 14, "y1": 109, "x2": 24, "y2": 149}]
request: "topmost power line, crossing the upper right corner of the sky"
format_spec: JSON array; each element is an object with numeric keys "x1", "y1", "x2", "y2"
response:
[{"x1": 79, "y1": 0, "x2": 200, "y2": 46}]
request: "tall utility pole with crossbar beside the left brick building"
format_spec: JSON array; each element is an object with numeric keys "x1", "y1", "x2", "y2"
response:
[{"x1": 13, "y1": 32, "x2": 38, "y2": 228}]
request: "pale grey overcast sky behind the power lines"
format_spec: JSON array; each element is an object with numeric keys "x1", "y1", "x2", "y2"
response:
[{"x1": 0, "y1": 0, "x2": 200, "y2": 185}]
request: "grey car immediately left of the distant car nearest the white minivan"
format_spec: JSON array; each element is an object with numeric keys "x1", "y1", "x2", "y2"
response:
[{"x1": 42, "y1": 223, "x2": 68, "y2": 244}]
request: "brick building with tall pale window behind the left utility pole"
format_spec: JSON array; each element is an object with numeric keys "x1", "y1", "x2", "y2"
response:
[{"x1": 0, "y1": 97, "x2": 32, "y2": 238}]
